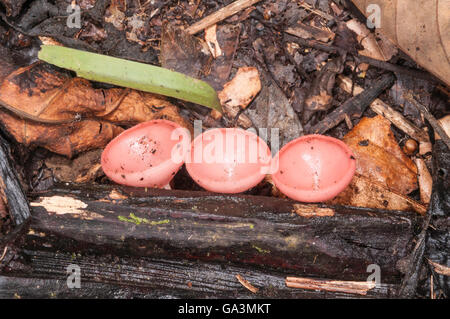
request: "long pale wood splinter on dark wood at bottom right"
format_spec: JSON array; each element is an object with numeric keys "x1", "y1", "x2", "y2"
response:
[{"x1": 286, "y1": 277, "x2": 376, "y2": 295}]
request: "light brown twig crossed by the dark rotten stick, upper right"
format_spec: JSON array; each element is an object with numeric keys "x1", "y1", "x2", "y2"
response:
[{"x1": 338, "y1": 75, "x2": 429, "y2": 143}]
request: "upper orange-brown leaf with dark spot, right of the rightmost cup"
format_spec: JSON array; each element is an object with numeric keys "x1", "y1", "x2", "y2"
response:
[{"x1": 343, "y1": 115, "x2": 417, "y2": 195}]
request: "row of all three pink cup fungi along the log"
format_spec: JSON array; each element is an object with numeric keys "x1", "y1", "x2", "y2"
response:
[{"x1": 101, "y1": 120, "x2": 356, "y2": 202}]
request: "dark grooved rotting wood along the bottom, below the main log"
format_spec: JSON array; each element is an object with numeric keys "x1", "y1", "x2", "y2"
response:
[{"x1": 0, "y1": 250, "x2": 398, "y2": 298}]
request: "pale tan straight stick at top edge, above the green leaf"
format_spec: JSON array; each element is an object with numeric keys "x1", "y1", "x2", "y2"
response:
[{"x1": 186, "y1": 0, "x2": 261, "y2": 34}]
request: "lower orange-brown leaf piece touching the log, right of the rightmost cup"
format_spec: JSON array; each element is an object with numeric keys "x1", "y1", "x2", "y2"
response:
[{"x1": 329, "y1": 174, "x2": 427, "y2": 215}]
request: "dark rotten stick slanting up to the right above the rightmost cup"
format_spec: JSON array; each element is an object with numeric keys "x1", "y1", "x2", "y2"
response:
[{"x1": 309, "y1": 73, "x2": 395, "y2": 134}]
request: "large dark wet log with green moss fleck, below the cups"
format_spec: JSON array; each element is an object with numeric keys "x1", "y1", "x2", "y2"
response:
[{"x1": 0, "y1": 185, "x2": 422, "y2": 283}]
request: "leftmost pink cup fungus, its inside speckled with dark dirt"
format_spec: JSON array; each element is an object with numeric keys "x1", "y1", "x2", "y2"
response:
[{"x1": 101, "y1": 120, "x2": 190, "y2": 188}]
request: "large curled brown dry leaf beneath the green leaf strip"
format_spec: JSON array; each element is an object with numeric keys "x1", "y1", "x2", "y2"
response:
[{"x1": 0, "y1": 63, "x2": 190, "y2": 157}]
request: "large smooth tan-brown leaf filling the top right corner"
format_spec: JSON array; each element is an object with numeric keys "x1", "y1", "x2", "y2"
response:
[{"x1": 352, "y1": 0, "x2": 450, "y2": 85}]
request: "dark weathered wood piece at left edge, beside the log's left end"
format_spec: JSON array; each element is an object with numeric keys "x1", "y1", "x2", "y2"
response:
[{"x1": 0, "y1": 136, "x2": 30, "y2": 225}]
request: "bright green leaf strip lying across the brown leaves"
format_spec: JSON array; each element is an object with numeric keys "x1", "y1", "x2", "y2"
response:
[{"x1": 39, "y1": 45, "x2": 222, "y2": 112}]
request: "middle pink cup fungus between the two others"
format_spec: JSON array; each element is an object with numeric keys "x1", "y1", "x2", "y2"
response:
[{"x1": 186, "y1": 128, "x2": 272, "y2": 193}]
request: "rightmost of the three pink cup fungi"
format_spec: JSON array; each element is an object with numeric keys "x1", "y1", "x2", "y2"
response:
[{"x1": 272, "y1": 135, "x2": 356, "y2": 202}]
